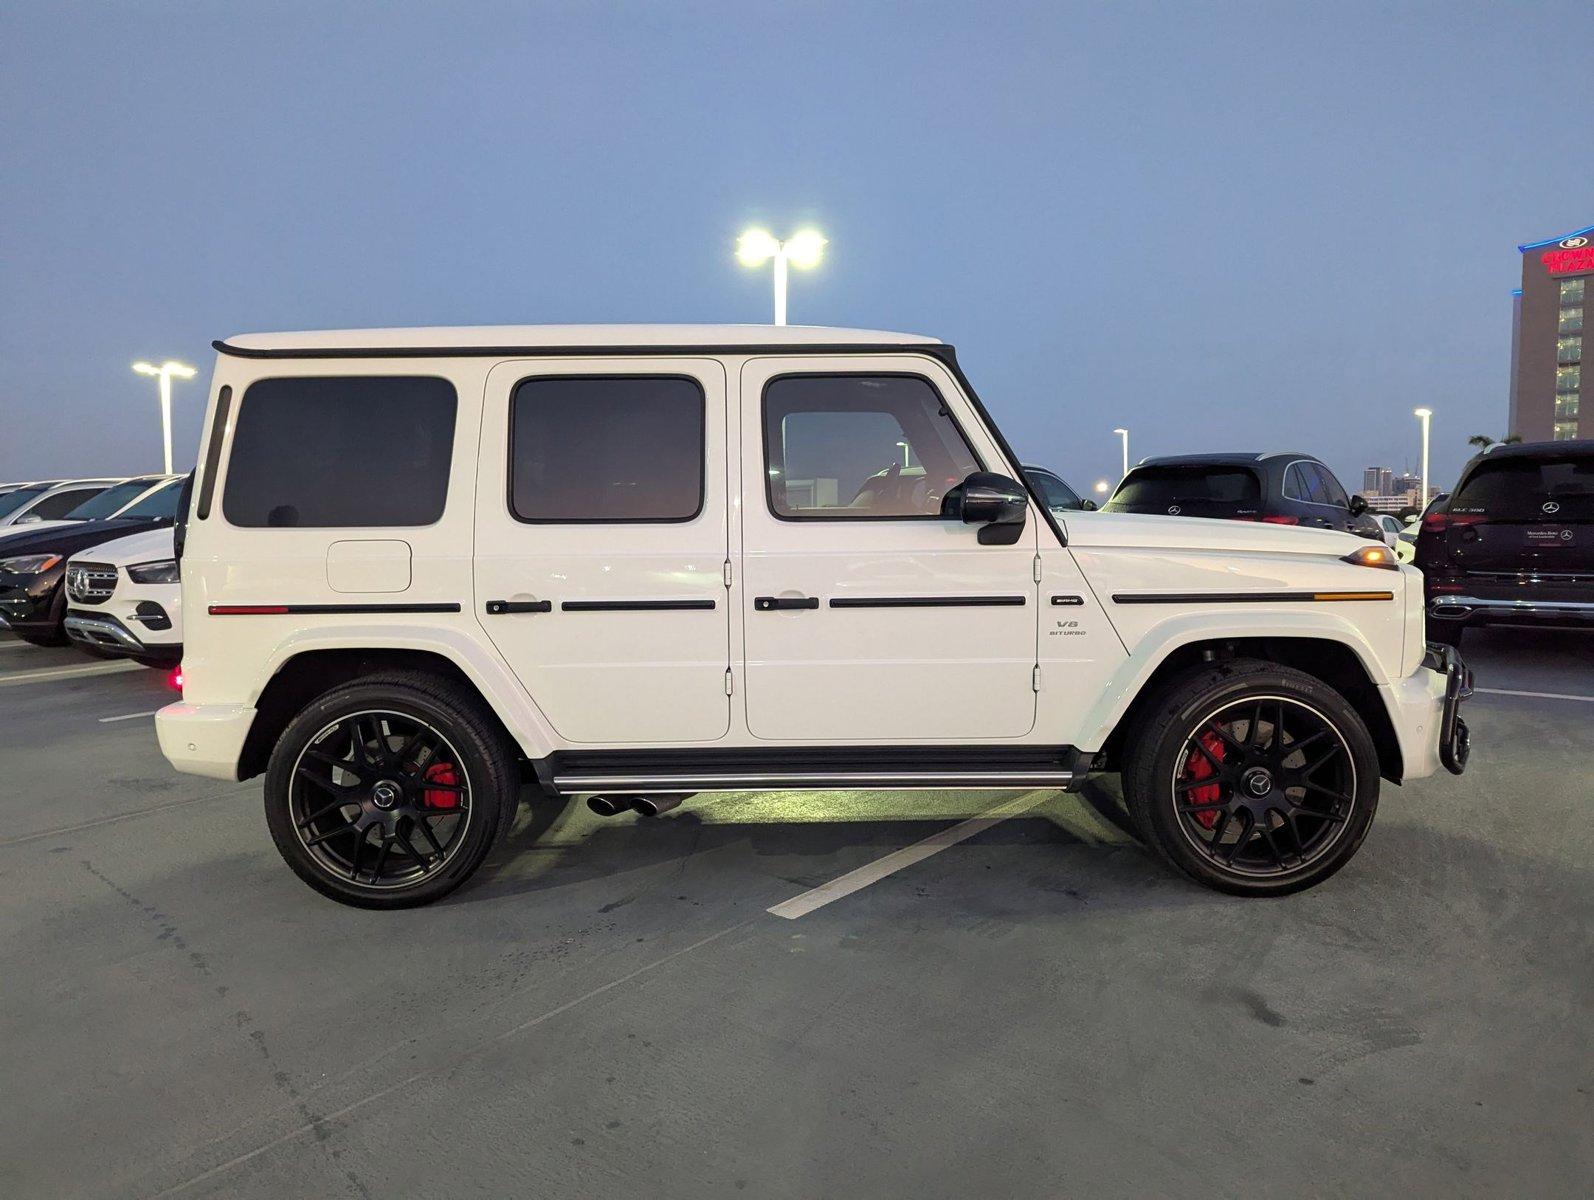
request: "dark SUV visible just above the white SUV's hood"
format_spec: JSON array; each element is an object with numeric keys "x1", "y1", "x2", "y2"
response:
[{"x1": 1101, "y1": 454, "x2": 1384, "y2": 540}]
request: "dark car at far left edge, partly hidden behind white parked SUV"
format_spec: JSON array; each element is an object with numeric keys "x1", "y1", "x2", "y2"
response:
[{"x1": 0, "y1": 478, "x2": 183, "y2": 645}]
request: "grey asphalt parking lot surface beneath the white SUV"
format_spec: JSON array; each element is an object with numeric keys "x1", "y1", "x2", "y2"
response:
[{"x1": 0, "y1": 633, "x2": 1594, "y2": 1200}]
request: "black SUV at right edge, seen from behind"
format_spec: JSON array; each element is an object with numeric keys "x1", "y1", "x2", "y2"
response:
[{"x1": 1414, "y1": 440, "x2": 1594, "y2": 645}]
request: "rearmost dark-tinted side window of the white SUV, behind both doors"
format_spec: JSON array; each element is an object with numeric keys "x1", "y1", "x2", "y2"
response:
[{"x1": 222, "y1": 375, "x2": 457, "y2": 529}]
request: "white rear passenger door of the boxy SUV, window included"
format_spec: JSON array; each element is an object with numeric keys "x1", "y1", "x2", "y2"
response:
[{"x1": 475, "y1": 359, "x2": 730, "y2": 746}]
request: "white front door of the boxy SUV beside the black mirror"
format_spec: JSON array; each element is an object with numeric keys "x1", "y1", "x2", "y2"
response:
[{"x1": 740, "y1": 355, "x2": 1039, "y2": 744}]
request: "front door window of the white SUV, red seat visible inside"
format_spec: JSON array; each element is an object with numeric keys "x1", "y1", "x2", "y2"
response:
[{"x1": 764, "y1": 375, "x2": 980, "y2": 520}]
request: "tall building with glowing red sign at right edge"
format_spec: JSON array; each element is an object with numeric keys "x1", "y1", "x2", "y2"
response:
[{"x1": 1508, "y1": 225, "x2": 1594, "y2": 441}]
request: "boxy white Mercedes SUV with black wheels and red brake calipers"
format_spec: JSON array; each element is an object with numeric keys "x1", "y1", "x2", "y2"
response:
[{"x1": 156, "y1": 325, "x2": 1470, "y2": 907}]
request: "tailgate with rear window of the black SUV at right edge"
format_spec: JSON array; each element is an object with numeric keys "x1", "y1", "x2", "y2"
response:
[{"x1": 1444, "y1": 451, "x2": 1594, "y2": 583}]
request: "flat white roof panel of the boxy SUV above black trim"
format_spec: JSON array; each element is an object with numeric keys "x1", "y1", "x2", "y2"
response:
[{"x1": 226, "y1": 325, "x2": 940, "y2": 351}]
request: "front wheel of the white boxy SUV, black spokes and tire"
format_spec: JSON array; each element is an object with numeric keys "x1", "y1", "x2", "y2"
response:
[{"x1": 1122, "y1": 660, "x2": 1379, "y2": 896}]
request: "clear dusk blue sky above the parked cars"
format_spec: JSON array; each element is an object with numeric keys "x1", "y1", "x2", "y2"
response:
[{"x1": 0, "y1": 0, "x2": 1594, "y2": 489}]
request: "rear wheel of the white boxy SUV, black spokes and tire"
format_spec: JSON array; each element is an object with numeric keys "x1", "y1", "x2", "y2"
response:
[{"x1": 265, "y1": 673, "x2": 520, "y2": 908}]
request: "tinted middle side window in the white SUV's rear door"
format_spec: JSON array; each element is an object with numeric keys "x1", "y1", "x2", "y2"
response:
[{"x1": 508, "y1": 375, "x2": 705, "y2": 524}]
